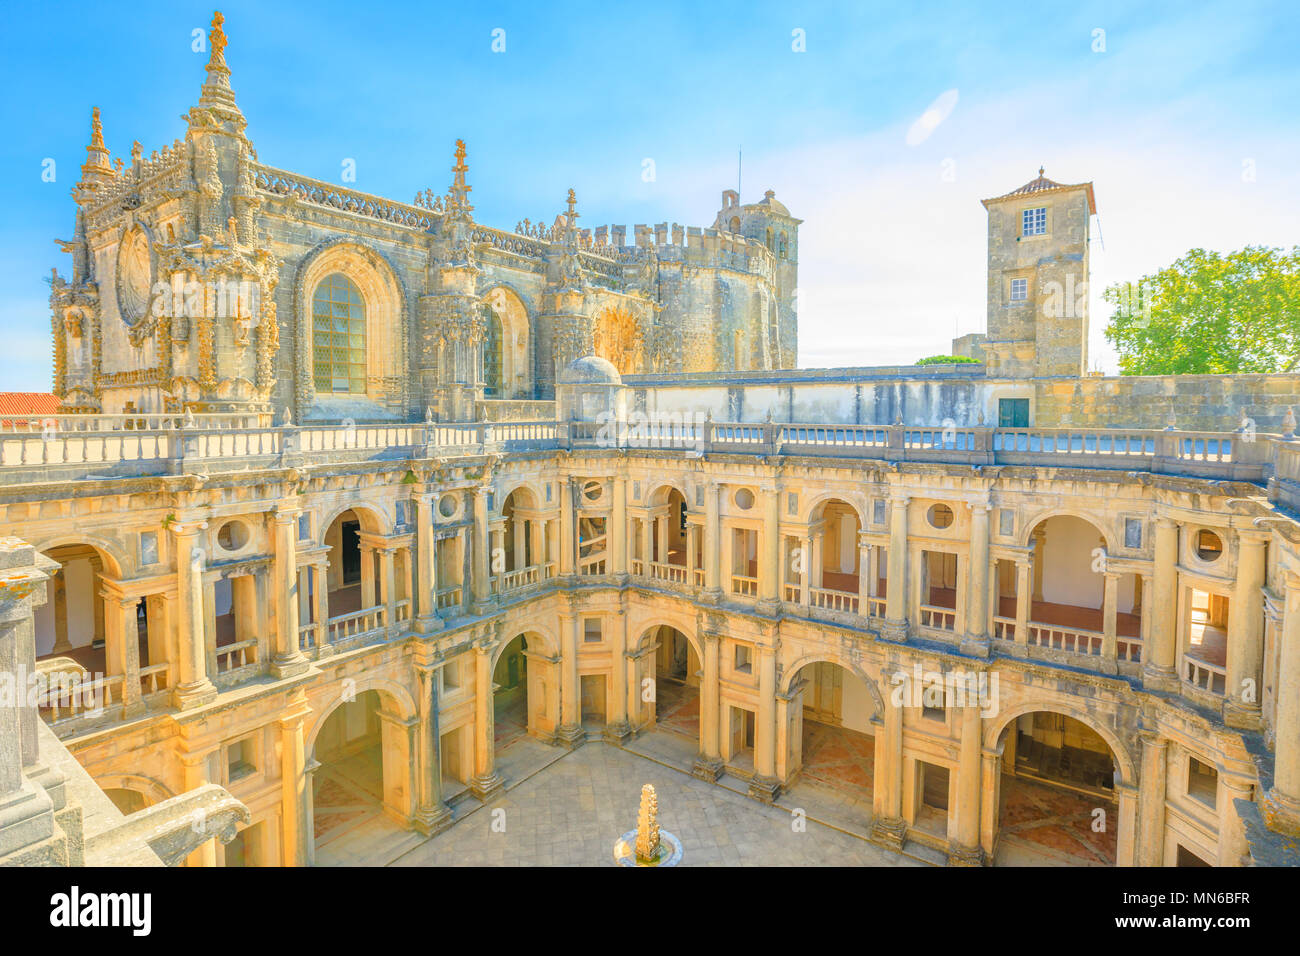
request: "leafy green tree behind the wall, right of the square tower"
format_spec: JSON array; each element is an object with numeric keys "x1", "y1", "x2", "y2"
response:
[{"x1": 1104, "y1": 246, "x2": 1300, "y2": 375}]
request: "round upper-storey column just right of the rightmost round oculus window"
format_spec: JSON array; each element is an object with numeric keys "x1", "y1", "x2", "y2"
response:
[{"x1": 1223, "y1": 531, "x2": 1268, "y2": 728}]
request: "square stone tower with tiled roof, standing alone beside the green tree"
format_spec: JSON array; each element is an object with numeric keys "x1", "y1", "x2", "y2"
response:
[{"x1": 983, "y1": 168, "x2": 1097, "y2": 378}]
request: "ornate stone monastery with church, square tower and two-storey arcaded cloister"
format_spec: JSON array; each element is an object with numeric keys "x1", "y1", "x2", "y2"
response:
[{"x1": 0, "y1": 14, "x2": 1300, "y2": 866}]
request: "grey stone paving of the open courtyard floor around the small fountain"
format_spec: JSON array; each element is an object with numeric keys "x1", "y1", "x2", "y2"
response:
[{"x1": 393, "y1": 741, "x2": 919, "y2": 866}]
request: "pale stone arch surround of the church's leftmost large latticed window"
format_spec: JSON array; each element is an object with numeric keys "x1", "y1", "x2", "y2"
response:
[{"x1": 294, "y1": 235, "x2": 410, "y2": 421}]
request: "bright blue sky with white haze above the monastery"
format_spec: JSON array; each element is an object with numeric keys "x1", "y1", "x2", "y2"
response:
[{"x1": 0, "y1": 1, "x2": 1300, "y2": 390}]
